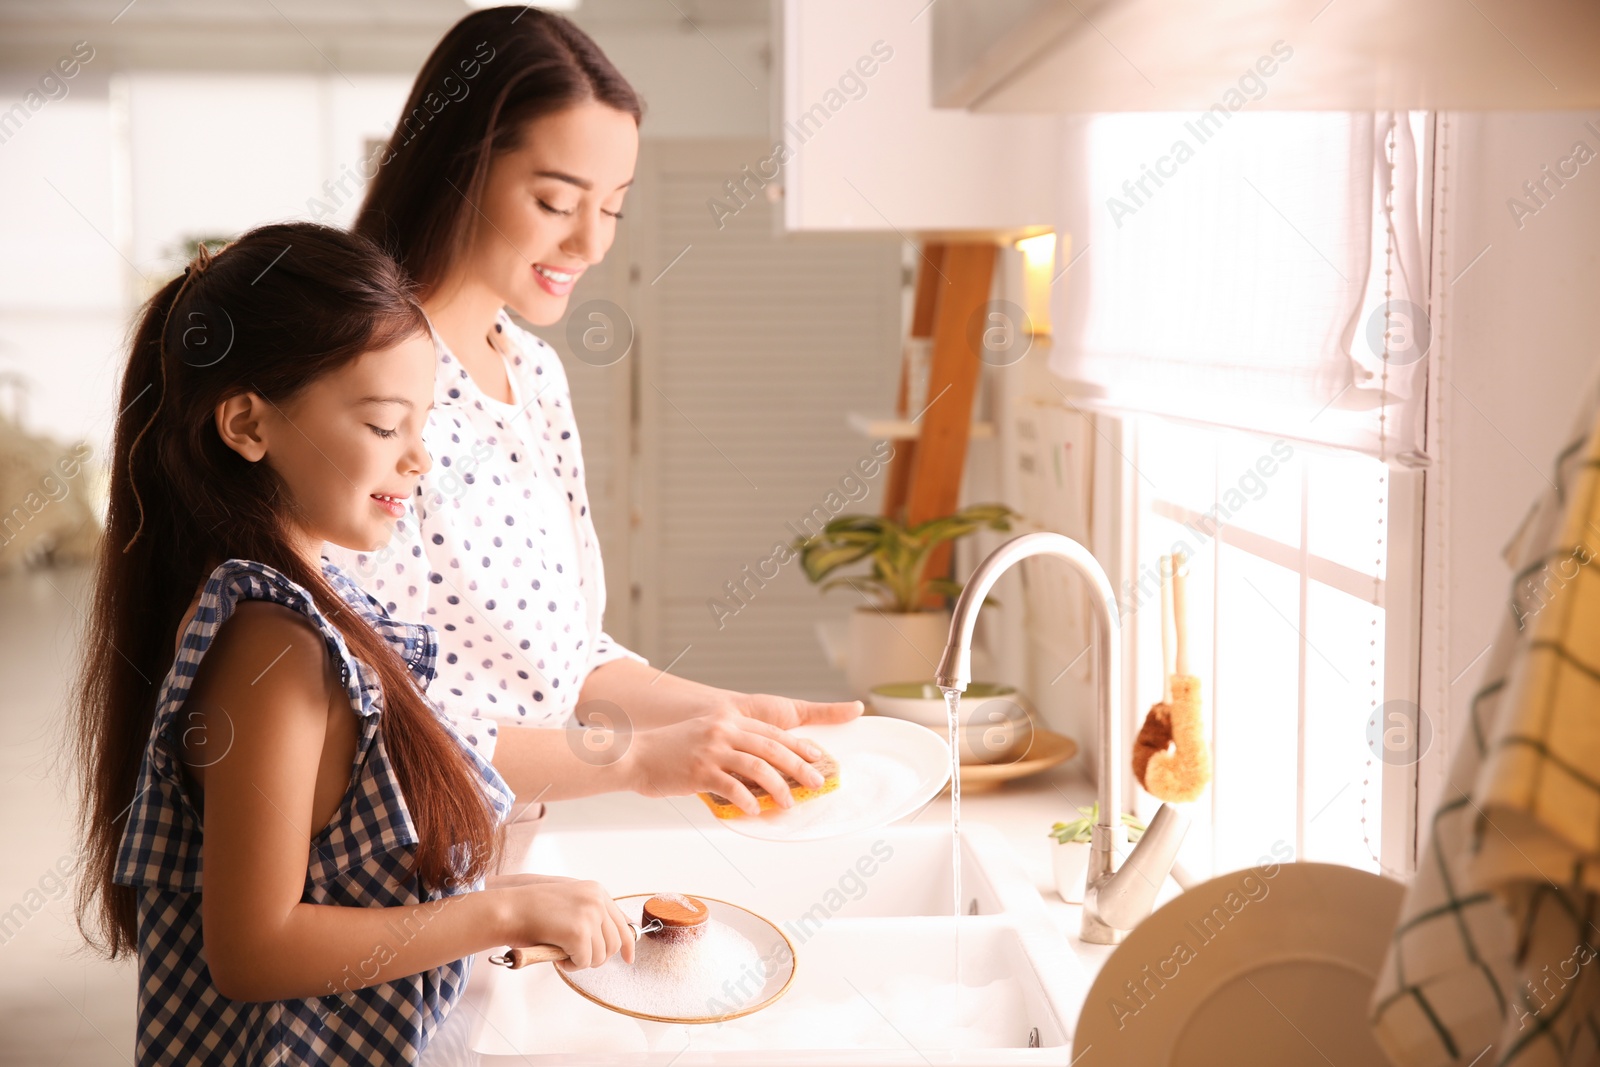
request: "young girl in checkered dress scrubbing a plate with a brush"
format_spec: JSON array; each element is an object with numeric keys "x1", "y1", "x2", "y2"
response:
[{"x1": 77, "y1": 224, "x2": 632, "y2": 1065}]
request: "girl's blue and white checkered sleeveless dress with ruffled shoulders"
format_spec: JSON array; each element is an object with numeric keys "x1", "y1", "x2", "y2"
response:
[{"x1": 117, "y1": 560, "x2": 512, "y2": 1067}]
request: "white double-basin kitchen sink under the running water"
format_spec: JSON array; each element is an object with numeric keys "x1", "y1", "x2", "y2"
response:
[{"x1": 472, "y1": 824, "x2": 1090, "y2": 1067}]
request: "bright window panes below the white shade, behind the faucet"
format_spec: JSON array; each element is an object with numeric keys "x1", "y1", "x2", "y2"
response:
[{"x1": 1123, "y1": 416, "x2": 1416, "y2": 877}]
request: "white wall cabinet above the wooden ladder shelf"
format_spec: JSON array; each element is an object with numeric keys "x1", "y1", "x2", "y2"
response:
[{"x1": 774, "y1": 0, "x2": 1059, "y2": 235}]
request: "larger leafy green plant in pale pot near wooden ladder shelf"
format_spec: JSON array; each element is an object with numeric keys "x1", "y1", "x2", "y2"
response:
[{"x1": 794, "y1": 504, "x2": 1014, "y2": 701}]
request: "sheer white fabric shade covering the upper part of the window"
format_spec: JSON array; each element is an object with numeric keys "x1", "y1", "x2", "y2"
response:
[{"x1": 1051, "y1": 107, "x2": 1430, "y2": 466}]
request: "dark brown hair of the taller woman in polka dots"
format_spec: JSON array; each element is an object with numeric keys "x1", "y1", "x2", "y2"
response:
[{"x1": 354, "y1": 6, "x2": 643, "y2": 294}]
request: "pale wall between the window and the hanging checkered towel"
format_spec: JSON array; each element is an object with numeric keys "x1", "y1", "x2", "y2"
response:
[{"x1": 1422, "y1": 112, "x2": 1600, "y2": 825}]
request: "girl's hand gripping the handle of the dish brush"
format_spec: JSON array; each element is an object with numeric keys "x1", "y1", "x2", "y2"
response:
[{"x1": 496, "y1": 877, "x2": 634, "y2": 971}]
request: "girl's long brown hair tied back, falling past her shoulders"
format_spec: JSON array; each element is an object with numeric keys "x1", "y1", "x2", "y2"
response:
[{"x1": 72, "y1": 222, "x2": 498, "y2": 957}]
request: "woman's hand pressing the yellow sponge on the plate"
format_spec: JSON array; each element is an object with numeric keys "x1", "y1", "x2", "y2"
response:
[{"x1": 627, "y1": 705, "x2": 832, "y2": 816}]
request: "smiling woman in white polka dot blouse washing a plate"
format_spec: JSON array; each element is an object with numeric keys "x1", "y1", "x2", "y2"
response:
[{"x1": 334, "y1": 8, "x2": 861, "y2": 851}]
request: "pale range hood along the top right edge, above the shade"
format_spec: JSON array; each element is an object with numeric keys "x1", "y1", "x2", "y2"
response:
[{"x1": 922, "y1": 0, "x2": 1600, "y2": 117}]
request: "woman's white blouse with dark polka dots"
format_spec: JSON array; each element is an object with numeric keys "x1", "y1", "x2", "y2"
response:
[{"x1": 325, "y1": 312, "x2": 643, "y2": 758}]
